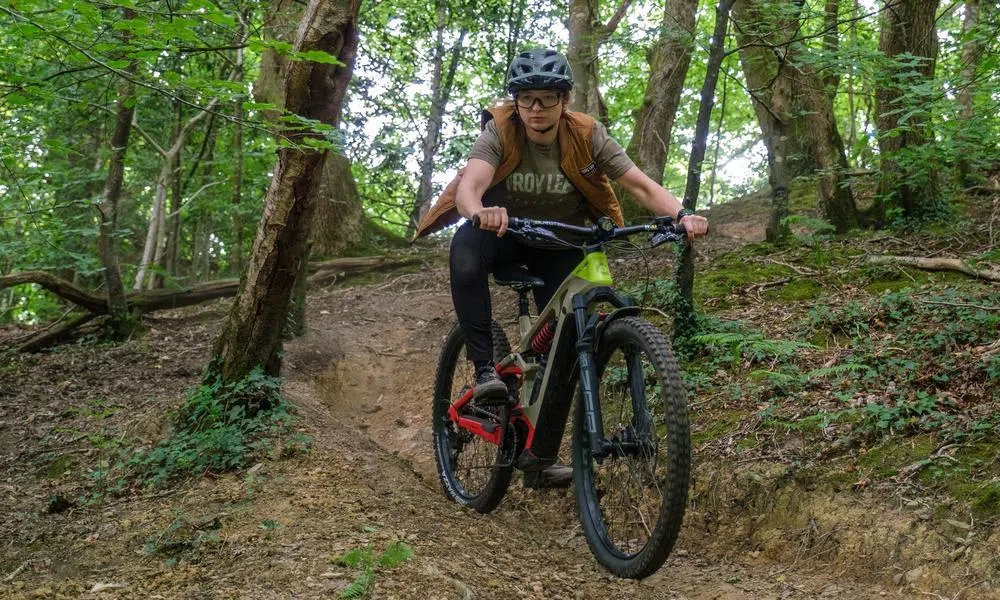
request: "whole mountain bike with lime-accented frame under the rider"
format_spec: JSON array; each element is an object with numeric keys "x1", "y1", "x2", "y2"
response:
[{"x1": 433, "y1": 217, "x2": 691, "y2": 579}]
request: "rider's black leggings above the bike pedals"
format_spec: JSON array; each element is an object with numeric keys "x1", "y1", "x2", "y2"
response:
[{"x1": 449, "y1": 223, "x2": 583, "y2": 366}]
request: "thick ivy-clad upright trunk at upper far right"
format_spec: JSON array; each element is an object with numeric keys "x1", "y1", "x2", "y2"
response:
[{"x1": 872, "y1": 0, "x2": 943, "y2": 223}]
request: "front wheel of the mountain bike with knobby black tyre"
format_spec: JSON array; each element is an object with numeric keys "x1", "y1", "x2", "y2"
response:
[{"x1": 573, "y1": 317, "x2": 691, "y2": 579}]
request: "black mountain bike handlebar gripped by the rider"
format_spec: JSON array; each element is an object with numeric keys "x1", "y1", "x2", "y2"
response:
[{"x1": 472, "y1": 215, "x2": 687, "y2": 247}]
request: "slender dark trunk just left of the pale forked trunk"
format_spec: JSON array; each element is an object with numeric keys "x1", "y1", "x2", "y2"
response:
[{"x1": 97, "y1": 18, "x2": 137, "y2": 323}]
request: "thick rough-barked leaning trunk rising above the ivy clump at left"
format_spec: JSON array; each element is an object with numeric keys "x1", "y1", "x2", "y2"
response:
[{"x1": 212, "y1": 0, "x2": 360, "y2": 383}]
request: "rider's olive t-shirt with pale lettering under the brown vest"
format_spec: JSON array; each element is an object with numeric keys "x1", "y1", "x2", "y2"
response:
[{"x1": 469, "y1": 121, "x2": 635, "y2": 225}]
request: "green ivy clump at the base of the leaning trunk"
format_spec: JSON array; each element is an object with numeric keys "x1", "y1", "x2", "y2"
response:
[{"x1": 129, "y1": 368, "x2": 309, "y2": 485}]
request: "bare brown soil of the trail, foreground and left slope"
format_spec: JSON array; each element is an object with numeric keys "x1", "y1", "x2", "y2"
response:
[{"x1": 0, "y1": 209, "x2": 1000, "y2": 600}]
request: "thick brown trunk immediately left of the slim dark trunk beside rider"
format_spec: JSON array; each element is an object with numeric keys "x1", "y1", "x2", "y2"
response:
[{"x1": 621, "y1": 0, "x2": 698, "y2": 220}]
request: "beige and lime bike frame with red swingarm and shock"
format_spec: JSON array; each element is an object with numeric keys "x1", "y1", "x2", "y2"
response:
[{"x1": 449, "y1": 242, "x2": 639, "y2": 468}]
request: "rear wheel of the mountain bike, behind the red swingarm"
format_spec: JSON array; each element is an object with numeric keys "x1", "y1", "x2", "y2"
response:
[{"x1": 433, "y1": 322, "x2": 517, "y2": 513}]
